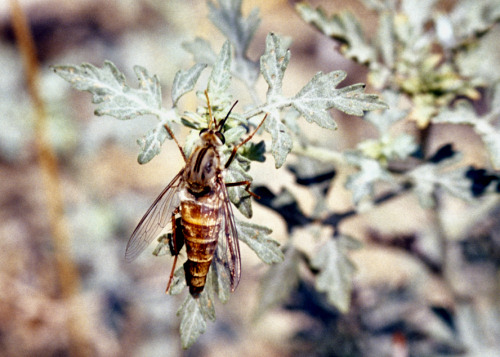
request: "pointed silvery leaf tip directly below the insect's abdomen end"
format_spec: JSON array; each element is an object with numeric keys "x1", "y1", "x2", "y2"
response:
[{"x1": 177, "y1": 294, "x2": 207, "y2": 349}]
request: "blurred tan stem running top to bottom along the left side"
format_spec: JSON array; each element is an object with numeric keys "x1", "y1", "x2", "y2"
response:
[{"x1": 10, "y1": 0, "x2": 90, "y2": 356}]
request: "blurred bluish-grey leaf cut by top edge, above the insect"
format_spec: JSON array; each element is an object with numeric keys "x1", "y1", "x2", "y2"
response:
[{"x1": 208, "y1": 0, "x2": 260, "y2": 57}]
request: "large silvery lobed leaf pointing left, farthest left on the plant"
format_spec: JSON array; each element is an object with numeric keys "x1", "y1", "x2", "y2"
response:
[{"x1": 52, "y1": 61, "x2": 161, "y2": 119}]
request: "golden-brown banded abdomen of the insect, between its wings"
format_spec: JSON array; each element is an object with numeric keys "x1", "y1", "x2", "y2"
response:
[{"x1": 181, "y1": 190, "x2": 222, "y2": 297}]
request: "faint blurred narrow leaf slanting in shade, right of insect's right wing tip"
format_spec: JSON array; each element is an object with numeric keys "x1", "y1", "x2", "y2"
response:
[{"x1": 255, "y1": 246, "x2": 301, "y2": 318}]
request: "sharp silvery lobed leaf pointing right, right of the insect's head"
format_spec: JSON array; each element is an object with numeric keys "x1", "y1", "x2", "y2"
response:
[{"x1": 292, "y1": 71, "x2": 387, "y2": 129}]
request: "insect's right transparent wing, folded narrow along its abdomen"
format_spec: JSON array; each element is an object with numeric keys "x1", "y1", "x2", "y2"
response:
[{"x1": 215, "y1": 179, "x2": 241, "y2": 292}]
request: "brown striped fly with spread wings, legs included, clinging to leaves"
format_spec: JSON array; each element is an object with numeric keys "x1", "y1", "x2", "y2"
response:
[{"x1": 125, "y1": 91, "x2": 267, "y2": 298}]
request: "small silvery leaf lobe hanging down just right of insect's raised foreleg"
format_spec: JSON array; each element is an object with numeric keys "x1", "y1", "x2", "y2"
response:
[{"x1": 264, "y1": 109, "x2": 293, "y2": 169}]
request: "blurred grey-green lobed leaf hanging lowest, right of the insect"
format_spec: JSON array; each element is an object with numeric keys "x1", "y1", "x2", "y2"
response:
[{"x1": 311, "y1": 236, "x2": 360, "y2": 313}]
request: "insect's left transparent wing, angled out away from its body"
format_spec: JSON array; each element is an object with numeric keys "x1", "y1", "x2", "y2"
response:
[{"x1": 125, "y1": 170, "x2": 184, "y2": 262}]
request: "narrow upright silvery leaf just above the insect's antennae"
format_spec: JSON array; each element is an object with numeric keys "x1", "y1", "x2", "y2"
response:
[{"x1": 207, "y1": 41, "x2": 231, "y2": 101}]
